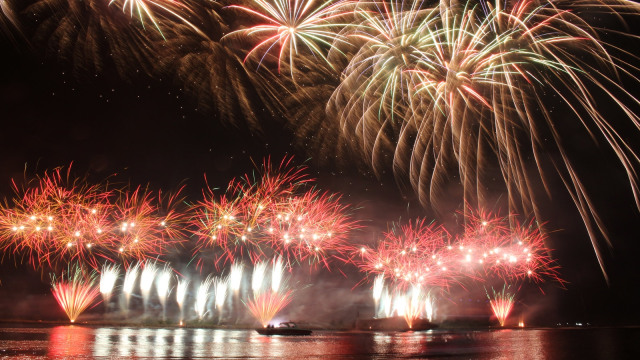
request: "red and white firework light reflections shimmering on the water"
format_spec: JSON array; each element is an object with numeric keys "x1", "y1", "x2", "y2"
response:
[{"x1": 40, "y1": 326, "x2": 550, "y2": 360}]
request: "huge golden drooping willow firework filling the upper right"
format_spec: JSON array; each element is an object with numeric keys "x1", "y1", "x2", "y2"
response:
[{"x1": 330, "y1": 0, "x2": 640, "y2": 282}]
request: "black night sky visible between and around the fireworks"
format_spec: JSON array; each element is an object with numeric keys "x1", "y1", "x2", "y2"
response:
[{"x1": 0, "y1": 0, "x2": 640, "y2": 324}]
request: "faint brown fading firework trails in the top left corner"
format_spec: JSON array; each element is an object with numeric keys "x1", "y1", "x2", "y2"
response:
[{"x1": 16, "y1": 0, "x2": 161, "y2": 79}]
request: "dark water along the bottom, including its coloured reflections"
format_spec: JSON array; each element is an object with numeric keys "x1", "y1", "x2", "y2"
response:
[{"x1": 0, "y1": 325, "x2": 640, "y2": 359}]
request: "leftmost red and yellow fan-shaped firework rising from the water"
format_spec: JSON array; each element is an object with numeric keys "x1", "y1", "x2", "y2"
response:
[{"x1": 51, "y1": 267, "x2": 100, "y2": 322}]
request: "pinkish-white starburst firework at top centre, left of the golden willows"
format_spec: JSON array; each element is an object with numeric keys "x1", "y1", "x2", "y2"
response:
[{"x1": 227, "y1": 0, "x2": 354, "y2": 72}]
